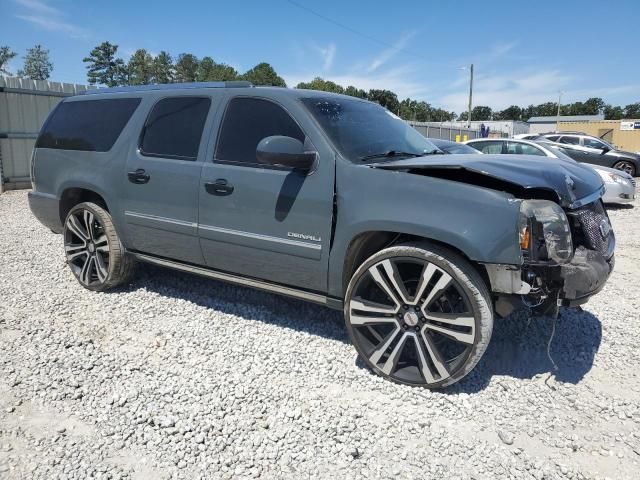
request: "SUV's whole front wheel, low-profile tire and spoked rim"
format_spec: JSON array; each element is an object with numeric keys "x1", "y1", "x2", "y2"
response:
[{"x1": 344, "y1": 242, "x2": 493, "y2": 388}]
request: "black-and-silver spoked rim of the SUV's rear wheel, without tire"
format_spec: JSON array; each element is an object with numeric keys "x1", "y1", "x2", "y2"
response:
[{"x1": 64, "y1": 209, "x2": 110, "y2": 288}]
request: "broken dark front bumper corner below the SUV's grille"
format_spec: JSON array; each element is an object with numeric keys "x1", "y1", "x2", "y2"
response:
[{"x1": 560, "y1": 248, "x2": 615, "y2": 307}]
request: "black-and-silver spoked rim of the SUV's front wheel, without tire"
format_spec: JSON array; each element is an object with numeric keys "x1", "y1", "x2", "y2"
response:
[{"x1": 345, "y1": 256, "x2": 480, "y2": 388}]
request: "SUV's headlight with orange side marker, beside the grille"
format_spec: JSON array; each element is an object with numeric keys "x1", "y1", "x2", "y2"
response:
[{"x1": 518, "y1": 200, "x2": 573, "y2": 264}]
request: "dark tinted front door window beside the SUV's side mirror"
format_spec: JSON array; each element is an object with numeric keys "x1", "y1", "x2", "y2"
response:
[{"x1": 216, "y1": 98, "x2": 305, "y2": 164}]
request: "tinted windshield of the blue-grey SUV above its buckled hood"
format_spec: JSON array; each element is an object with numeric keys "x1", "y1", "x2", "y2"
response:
[{"x1": 302, "y1": 97, "x2": 441, "y2": 162}]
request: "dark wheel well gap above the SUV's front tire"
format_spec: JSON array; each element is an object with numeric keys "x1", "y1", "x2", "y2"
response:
[{"x1": 342, "y1": 232, "x2": 491, "y2": 294}]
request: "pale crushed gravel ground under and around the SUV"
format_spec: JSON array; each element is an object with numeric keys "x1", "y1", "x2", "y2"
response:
[{"x1": 0, "y1": 192, "x2": 640, "y2": 479}]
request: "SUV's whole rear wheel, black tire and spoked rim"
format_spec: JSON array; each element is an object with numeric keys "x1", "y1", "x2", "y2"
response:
[{"x1": 63, "y1": 202, "x2": 135, "y2": 292}]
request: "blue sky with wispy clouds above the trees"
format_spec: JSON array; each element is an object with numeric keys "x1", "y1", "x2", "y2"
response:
[{"x1": 0, "y1": 0, "x2": 640, "y2": 112}]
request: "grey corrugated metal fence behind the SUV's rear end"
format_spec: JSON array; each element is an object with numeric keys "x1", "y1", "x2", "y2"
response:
[{"x1": 0, "y1": 76, "x2": 91, "y2": 192}]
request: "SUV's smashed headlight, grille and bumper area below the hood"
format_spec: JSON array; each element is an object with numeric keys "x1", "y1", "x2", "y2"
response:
[{"x1": 487, "y1": 195, "x2": 615, "y2": 316}]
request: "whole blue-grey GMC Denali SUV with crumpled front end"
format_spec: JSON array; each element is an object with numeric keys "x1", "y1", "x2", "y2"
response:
[{"x1": 29, "y1": 82, "x2": 615, "y2": 388}]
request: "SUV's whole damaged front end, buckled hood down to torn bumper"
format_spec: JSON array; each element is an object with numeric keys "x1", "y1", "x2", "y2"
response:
[{"x1": 372, "y1": 155, "x2": 615, "y2": 316}]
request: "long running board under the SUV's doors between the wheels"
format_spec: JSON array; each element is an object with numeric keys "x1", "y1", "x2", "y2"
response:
[{"x1": 129, "y1": 252, "x2": 343, "y2": 310}]
